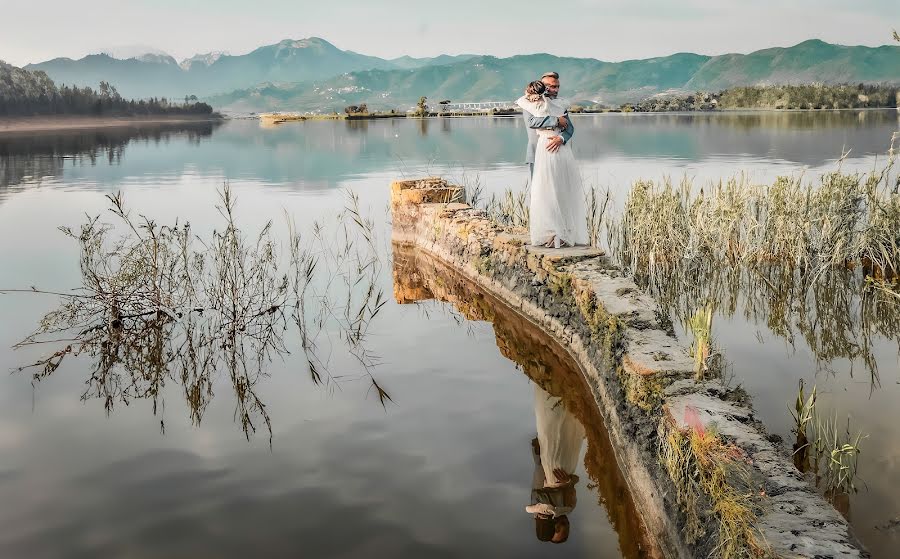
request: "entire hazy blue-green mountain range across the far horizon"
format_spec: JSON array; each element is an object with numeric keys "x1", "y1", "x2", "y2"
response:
[{"x1": 19, "y1": 37, "x2": 900, "y2": 112}]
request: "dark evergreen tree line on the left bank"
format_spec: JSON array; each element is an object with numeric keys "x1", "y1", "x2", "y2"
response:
[{"x1": 0, "y1": 61, "x2": 213, "y2": 116}]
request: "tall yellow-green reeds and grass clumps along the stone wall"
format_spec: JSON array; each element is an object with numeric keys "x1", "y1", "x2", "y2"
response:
[{"x1": 474, "y1": 139, "x2": 900, "y2": 528}]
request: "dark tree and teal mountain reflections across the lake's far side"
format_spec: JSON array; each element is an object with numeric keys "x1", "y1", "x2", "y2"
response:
[{"x1": 0, "y1": 111, "x2": 898, "y2": 189}]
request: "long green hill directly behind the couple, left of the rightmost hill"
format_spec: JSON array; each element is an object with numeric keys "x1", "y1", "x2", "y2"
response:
[{"x1": 208, "y1": 54, "x2": 709, "y2": 112}]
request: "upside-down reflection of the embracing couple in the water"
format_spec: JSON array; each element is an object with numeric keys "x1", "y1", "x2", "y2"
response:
[{"x1": 525, "y1": 383, "x2": 584, "y2": 543}]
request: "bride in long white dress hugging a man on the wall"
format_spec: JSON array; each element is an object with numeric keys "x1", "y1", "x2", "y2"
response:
[{"x1": 516, "y1": 81, "x2": 588, "y2": 248}]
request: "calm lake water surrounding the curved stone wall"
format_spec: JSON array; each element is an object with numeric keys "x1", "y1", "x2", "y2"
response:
[{"x1": 0, "y1": 111, "x2": 900, "y2": 558}]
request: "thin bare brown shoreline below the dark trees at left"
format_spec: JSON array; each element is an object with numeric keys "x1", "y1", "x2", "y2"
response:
[{"x1": 0, "y1": 115, "x2": 224, "y2": 134}]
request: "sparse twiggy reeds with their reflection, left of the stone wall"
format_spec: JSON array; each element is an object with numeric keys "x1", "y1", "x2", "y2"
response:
[{"x1": 7, "y1": 185, "x2": 390, "y2": 440}]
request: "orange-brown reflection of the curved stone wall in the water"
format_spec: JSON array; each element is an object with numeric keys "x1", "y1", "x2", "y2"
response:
[{"x1": 393, "y1": 245, "x2": 662, "y2": 559}]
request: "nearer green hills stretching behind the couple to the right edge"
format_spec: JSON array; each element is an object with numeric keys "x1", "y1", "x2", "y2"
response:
[{"x1": 210, "y1": 40, "x2": 900, "y2": 112}]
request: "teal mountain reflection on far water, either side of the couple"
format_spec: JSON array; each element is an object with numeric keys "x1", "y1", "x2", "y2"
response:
[{"x1": 244, "y1": 110, "x2": 898, "y2": 179}]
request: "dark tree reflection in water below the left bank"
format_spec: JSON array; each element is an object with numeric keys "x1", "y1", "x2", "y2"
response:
[{"x1": 0, "y1": 121, "x2": 222, "y2": 188}]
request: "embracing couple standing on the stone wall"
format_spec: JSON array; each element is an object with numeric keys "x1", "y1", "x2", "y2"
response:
[{"x1": 516, "y1": 72, "x2": 588, "y2": 248}]
